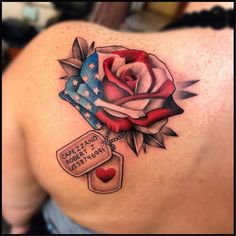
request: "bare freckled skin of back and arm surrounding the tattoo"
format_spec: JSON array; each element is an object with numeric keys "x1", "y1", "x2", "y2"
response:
[{"x1": 3, "y1": 2, "x2": 233, "y2": 233}]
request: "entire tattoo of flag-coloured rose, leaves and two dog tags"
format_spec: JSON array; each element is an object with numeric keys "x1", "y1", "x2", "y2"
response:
[{"x1": 57, "y1": 38, "x2": 198, "y2": 193}]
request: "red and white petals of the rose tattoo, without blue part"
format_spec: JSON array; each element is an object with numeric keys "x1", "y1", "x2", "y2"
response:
[{"x1": 93, "y1": 47, "x2": 183, "y2": 134}]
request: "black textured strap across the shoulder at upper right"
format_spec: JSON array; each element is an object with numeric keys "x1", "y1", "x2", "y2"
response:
[{"x1": 162, "y1": 6, "x2": 235, "y2": 31}]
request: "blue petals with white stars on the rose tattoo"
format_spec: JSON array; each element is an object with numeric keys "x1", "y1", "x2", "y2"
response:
[{"x1": 59, "y1": 53, "x2": 103, "y2": 129}]
